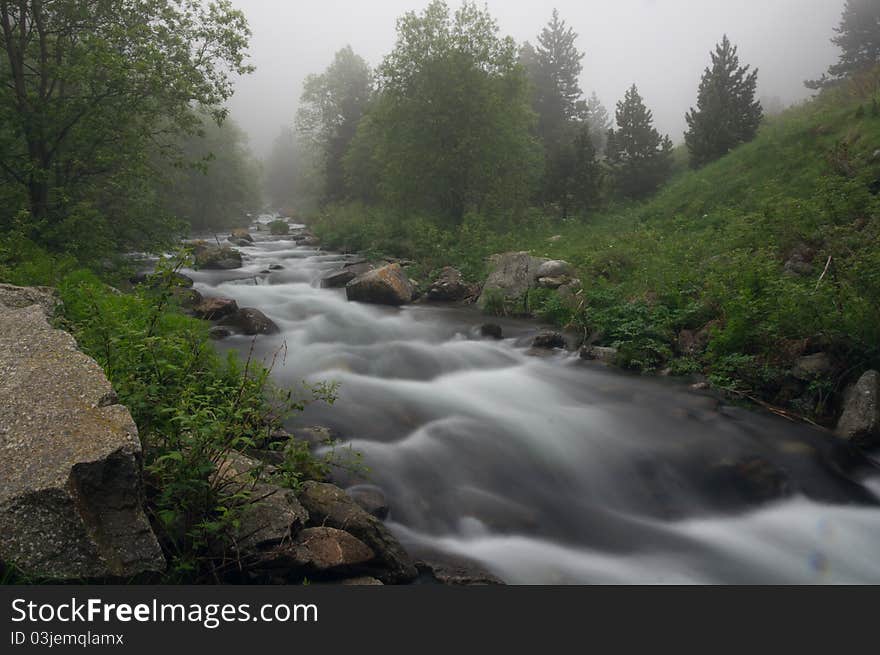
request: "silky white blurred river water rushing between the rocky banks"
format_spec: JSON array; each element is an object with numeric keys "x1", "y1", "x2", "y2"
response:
[{"x1": 187, "y1": 219, "x2": 880, "y2": 584}]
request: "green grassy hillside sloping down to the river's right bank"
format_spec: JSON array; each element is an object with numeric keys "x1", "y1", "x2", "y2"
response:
[{"x1": 315, "y1": 72, "x2": 880, "y2": 420}]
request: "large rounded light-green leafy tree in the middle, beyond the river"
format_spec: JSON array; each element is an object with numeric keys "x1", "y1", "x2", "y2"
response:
[{"x1": 348, "y1": 0, "x2": 540, "y2": 223}]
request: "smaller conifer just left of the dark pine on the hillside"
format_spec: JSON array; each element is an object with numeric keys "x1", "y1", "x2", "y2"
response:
[{"x1": 606, "y1": 85, "x2": 672, "y2": 198}]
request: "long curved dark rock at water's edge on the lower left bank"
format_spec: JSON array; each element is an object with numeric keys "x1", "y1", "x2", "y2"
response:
[{"x1": 299, "y1": 482, "x2": 418, "y2": 583}]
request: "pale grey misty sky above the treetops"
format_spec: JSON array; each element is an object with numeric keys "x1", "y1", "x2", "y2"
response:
[{"x1": 230, "y1": 0, "x2": 844, "y2": 156}]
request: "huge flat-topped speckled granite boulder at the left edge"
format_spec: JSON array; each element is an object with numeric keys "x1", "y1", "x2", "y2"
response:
[{"x1": 0, "y1": 298, "x2": 165, "y2": 580}]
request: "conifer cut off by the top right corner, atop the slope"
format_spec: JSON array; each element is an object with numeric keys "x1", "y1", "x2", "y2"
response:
[{"x1": 805, "y1": 0, "x2": 880, "y2": 89}]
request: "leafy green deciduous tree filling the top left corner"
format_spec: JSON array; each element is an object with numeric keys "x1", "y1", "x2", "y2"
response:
[{"x1": 0, "y1": 0, "x2": 252, "y2": 254}]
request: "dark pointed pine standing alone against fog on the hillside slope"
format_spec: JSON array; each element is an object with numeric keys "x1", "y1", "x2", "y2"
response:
[{"x1": 685, "y1": 35, "x2": 764, "y2": 168}]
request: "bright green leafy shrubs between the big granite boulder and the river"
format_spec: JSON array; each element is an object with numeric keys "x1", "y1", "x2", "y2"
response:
[{"x1": 51, "y1": 263, "x2": 334, "y2": 581}]
